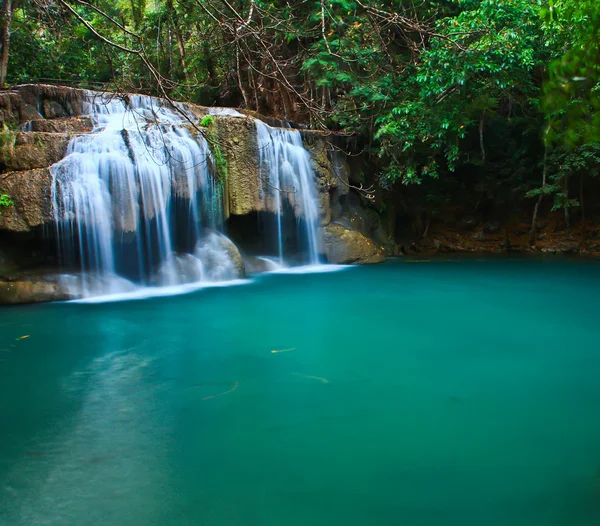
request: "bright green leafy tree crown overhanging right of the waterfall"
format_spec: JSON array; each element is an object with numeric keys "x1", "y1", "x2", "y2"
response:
[{"x1": 375, "y1": 0, "x2": 545, "y2": 183}]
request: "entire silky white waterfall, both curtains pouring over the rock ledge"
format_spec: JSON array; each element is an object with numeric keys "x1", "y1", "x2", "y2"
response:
[{"x1": 50, "y1": 92, "x2": 326, "y2": 297}]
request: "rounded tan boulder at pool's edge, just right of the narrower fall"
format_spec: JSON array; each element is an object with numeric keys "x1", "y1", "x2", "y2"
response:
[{"x1": 322, "y1": 223, "x2": 385, "y2": 264}]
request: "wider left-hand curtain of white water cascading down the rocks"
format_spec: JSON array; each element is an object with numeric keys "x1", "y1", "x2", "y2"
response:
[{"x1": 51, "y1": 93, "x2": 236, "y2": 296}]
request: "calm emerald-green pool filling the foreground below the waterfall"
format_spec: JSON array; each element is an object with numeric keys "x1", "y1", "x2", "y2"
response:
[{"x1": 0, "y1": 260, "x2": 600, "y2": 526}]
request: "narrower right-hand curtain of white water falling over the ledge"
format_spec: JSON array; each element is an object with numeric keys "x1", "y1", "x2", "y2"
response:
[{"x1": 255, "y1": 120, "x2": 319, "y2": 265}]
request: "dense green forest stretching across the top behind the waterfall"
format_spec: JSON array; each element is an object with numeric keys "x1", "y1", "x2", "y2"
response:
[{"x1": 0, "y1": 0, "x2": 600, "y2": 223}]
